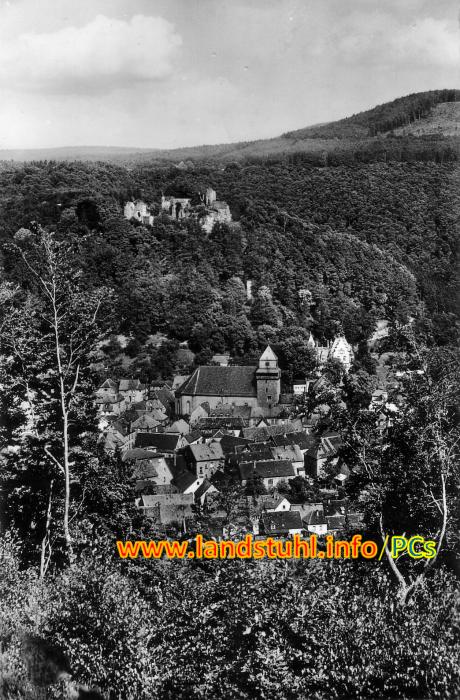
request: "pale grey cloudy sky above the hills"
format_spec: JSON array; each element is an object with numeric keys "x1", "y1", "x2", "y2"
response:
[{"x1": 0, "y1": 0, "x2": 460, "y2": 149}]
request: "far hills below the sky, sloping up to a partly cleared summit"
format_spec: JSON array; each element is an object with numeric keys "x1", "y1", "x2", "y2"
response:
[{"x1": 0, "y1": 90, "x2": 460, "y2": 167}]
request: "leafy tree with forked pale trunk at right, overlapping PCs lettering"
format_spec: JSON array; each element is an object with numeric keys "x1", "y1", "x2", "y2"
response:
[{"x1": 336, "y1": 338, "x2": 460, "y2": 605}]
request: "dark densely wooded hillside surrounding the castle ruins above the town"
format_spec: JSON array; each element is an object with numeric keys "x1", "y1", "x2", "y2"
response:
[{"x1": 0, "y1": 156, "x2": 460, "y2": 356}]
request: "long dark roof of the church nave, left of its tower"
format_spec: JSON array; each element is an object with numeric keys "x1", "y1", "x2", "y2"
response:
[{"x1": 176, "y1": 366, "x2": 257, "y2": 397}]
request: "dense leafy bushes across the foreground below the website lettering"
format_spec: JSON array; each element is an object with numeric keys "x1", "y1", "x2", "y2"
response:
[{"x1": 0, "y1": 537, "x2": 460, "y2": 700}]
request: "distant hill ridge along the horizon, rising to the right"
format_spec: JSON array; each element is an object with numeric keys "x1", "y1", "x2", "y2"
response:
[{"x1": 0, "y1": 89, "x2": 460, "y2": 164}]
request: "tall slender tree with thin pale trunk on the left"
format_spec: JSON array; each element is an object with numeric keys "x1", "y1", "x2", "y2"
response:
[{"x1": 1, "y1": 227, "x2": 108, "y2": 556}]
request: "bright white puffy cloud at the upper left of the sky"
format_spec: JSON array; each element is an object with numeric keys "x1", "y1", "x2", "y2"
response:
[{"x1": 0, "y1": 15, "x2": 182, "y2": 94}]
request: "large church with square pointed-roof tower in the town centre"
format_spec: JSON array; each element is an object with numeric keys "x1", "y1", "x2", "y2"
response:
[{"x1": 175, "y1": 345, "x2": 281, "y2": 415}]
